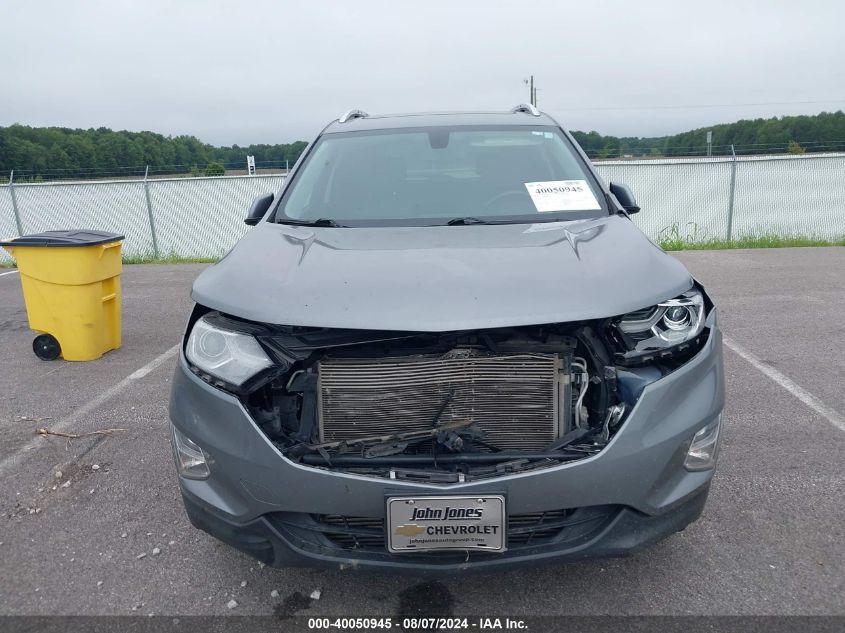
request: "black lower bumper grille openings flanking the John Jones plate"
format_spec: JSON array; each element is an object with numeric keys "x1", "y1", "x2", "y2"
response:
[{"x1": 308, "y1": 506, "x2": 619, "y2": 551}]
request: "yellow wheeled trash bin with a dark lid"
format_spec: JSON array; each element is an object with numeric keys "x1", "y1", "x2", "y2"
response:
[{"x1": 0, "y1": 231, "x2": 123, "y2": 360}]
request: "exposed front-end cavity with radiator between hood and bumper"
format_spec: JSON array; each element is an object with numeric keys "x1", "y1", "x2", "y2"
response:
[{"x1": 183, "y1": 311, "x2": 706, "y2": 483}]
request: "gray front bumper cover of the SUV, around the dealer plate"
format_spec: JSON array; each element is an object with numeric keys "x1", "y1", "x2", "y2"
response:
[{"x1": 170, "y1": 312, "x2": 724, "y2": 573}]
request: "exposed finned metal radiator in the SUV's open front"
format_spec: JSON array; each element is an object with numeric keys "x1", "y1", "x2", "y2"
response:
[{"x1": 319, "y1": 349, "x2": 569, "y2": 450}]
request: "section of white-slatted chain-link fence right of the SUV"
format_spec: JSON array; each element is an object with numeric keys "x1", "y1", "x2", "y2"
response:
[{"x1": 596, "y1": 153, "x2": 845, "y2": 241}]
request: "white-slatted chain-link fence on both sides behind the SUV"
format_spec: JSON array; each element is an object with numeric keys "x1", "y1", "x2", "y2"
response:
[{"x1": 0, "y1": 153, "x2": 845, "y2": 261}]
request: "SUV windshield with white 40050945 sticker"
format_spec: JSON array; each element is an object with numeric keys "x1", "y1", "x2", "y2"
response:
[{"x1": 275, "y1": 126, "x2": 606, "y2": 226}]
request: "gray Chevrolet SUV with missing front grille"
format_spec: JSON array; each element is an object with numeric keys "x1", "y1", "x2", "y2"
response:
[{"x1": 170, "y1": 105, "x2": 724, "y2": 574}]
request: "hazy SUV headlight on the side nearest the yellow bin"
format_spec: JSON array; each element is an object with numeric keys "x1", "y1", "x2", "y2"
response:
[{"x1": 185, "y1": 317, "x2": 273, "y2": 387}]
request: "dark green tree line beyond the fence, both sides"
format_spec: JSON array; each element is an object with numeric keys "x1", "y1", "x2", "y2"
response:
[{"x1": 0, "y1": 111, "x2": 845, "y2": 178}]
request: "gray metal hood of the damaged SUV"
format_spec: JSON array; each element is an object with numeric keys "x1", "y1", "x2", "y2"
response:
[{"x1": 192, "y1": 216, "x2": 692, "y2": 332}]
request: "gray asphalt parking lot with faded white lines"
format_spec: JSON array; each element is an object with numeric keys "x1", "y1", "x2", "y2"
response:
[{"x1": 0, "y1": 248, "x2": 845, "y2": 616}]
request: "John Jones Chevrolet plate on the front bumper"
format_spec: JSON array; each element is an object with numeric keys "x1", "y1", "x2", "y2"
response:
[{"x1": 387, "y1": 495, "x2": 505, "y2": 552}]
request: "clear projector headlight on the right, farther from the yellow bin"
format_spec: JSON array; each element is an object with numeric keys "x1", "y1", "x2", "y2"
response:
[{"x1": 615, "y1": 289, "x2": 705, "y2": 360}]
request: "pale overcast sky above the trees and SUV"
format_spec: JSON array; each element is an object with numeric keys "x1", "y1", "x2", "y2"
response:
[{"x1": 0, "y1": 0, "x2": 845, "y2": 145}]
